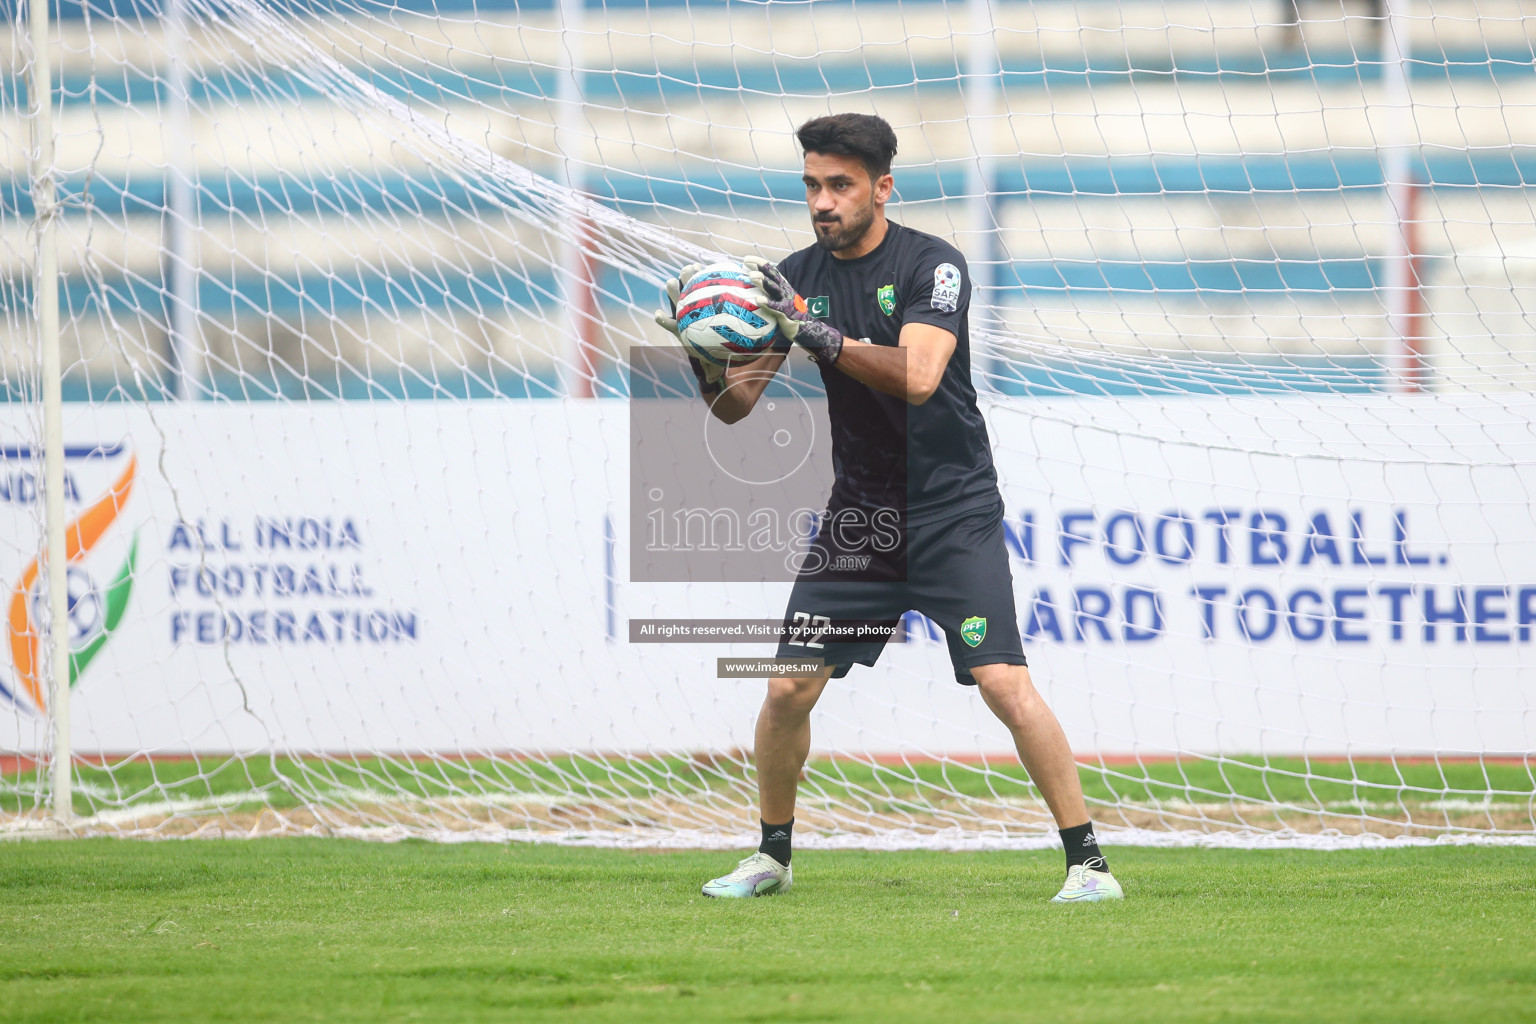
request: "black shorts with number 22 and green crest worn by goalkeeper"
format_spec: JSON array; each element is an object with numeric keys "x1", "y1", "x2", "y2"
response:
[{"x1": 777, "y1": 502, "x2": 1029, "y2": 686}]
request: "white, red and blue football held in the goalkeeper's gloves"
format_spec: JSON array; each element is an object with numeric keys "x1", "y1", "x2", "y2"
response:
[{"x1": 677, "y1": 261, "x2": 779, "y2": 367}]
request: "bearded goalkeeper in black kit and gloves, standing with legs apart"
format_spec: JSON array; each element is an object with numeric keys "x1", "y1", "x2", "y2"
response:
[{"x1": 657, "y1": 114, "x2": 1121, "y2": 903}]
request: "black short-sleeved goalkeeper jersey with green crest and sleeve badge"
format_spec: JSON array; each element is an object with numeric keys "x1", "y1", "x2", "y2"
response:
[{"x1": 779, "y1": 223, "x2": 1000, "y2": 525}]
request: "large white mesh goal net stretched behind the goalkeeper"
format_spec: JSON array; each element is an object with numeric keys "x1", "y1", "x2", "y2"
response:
[{"x1": 0, "y1": 0, "x2": 1536, "y2": 847}]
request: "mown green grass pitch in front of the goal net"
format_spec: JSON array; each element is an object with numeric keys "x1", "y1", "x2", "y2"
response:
[{"x1": 0, "y1": 840, "x2": 1536, "y2": 1024}]
